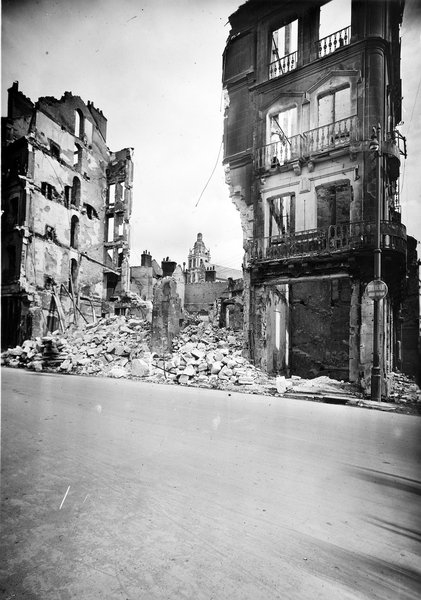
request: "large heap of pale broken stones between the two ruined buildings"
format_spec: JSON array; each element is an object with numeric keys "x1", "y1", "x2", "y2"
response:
[{"x1": 2, "y1": 316, "x2": 276, "y2": 393}]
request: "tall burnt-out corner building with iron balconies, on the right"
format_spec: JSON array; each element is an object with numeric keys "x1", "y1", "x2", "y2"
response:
[{"x1": 223, "y1": 0, "x2": 418, "y2": 387}]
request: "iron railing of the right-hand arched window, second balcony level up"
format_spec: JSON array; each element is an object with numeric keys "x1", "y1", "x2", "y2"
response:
[{"x1": 303, "y1": 115, "x2": 358, "y2": 156}]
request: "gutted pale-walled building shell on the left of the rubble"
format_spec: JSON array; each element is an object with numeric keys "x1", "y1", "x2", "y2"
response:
[{"x1": 2, "y1": 82, "x2": 133, "y2": 348}]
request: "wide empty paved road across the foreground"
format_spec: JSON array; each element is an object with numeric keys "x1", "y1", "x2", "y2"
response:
[{"x1": 0, "y1": 369, "x2": 421, "y2": 600}]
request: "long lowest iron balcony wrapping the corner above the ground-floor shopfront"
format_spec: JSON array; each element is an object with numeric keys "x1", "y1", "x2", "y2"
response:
[{"x1": 246, "y1": 221, "x2": 406, "y2": 263}]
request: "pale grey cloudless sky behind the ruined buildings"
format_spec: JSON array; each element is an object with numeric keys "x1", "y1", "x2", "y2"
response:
[{"x1": 2, "y1": 0, "x2": 421, "y2": 268}]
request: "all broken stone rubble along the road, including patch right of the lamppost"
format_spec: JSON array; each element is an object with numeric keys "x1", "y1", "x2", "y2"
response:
[{"x1": 1, "y1": 316, "x2": 421, "y2": 413}]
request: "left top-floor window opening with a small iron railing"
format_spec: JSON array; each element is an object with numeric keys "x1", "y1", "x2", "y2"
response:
[{"x1": 269, "y1": 20, "x2": 298, "y2": 78}]
